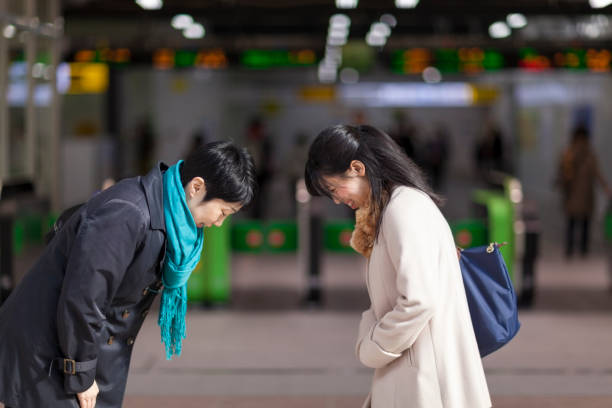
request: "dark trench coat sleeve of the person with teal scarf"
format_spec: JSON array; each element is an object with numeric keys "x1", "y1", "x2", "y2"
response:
[{"x1": 57, "y1": 199, "x2": 145, "y2": 394}]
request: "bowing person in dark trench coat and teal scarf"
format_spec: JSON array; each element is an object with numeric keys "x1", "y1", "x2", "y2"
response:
[{"x1": 0, "y1": 142, "x2": 256, "y2": 408}]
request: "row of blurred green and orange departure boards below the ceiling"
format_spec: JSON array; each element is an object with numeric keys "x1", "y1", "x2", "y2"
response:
[{"x1": 64, "y1": 47, "x2": 612, "y2": 75}]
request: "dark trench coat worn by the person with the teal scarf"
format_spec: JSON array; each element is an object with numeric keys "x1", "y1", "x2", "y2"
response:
[{"x1": 0, "y1": 164, "x2": 167, "y2": 408}]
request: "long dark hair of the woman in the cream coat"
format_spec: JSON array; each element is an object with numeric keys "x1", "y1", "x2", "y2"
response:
[{"x1": 304, "y1": 125, "x2": 442, "y2": 237}]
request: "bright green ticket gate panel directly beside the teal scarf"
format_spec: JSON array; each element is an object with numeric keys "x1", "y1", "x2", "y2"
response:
[{"x1": 187, "y1": 219, "x2": 231, "y2": 304}]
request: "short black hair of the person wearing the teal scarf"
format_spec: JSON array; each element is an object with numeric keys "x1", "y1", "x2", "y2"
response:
[{"x1": 180, "y1": 142, "x2": 257, "y2": 206}]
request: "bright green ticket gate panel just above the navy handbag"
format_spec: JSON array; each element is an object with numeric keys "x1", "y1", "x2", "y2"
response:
[{"x1": 473, "y1": 190, "x2": 515, "y2": 279}]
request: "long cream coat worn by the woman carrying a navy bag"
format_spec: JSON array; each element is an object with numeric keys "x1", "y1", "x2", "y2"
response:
[{"x1": 355, "y1": 186, "x2": 491, "y2": 408}]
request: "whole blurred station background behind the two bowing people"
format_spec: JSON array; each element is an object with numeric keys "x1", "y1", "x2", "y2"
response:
[{"x1": 0, "y1": 0, "x2": 612, "y2": 407}]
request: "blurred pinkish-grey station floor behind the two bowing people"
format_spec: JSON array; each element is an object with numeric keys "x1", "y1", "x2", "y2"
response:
[{"x1": 4, "y1": 241, "x2": 612, "y2": 408}]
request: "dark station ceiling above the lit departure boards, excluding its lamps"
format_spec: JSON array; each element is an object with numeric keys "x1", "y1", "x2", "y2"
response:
[{"x1": 62, "y1": 0, "x2": 612, "y2": 52}]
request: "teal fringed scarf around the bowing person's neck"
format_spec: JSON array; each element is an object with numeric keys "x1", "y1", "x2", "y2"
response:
[{"x1": 158, "y1": 160, "x2": 204, "y2": 360}]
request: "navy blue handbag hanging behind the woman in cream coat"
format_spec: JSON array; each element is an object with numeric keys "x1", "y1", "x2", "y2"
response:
[{"x1": 459, "y1": 243, "x2": 521, "y2": 357}]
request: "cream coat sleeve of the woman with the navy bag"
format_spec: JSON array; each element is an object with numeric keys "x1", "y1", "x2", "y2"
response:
[{"x1": 359, "y1": 193, "x2": 439, "y2": 368}]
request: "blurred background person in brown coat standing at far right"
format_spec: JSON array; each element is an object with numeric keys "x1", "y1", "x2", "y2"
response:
[{"x1": 556, "y1": 126, "x2": 612, "y2": 258}]
